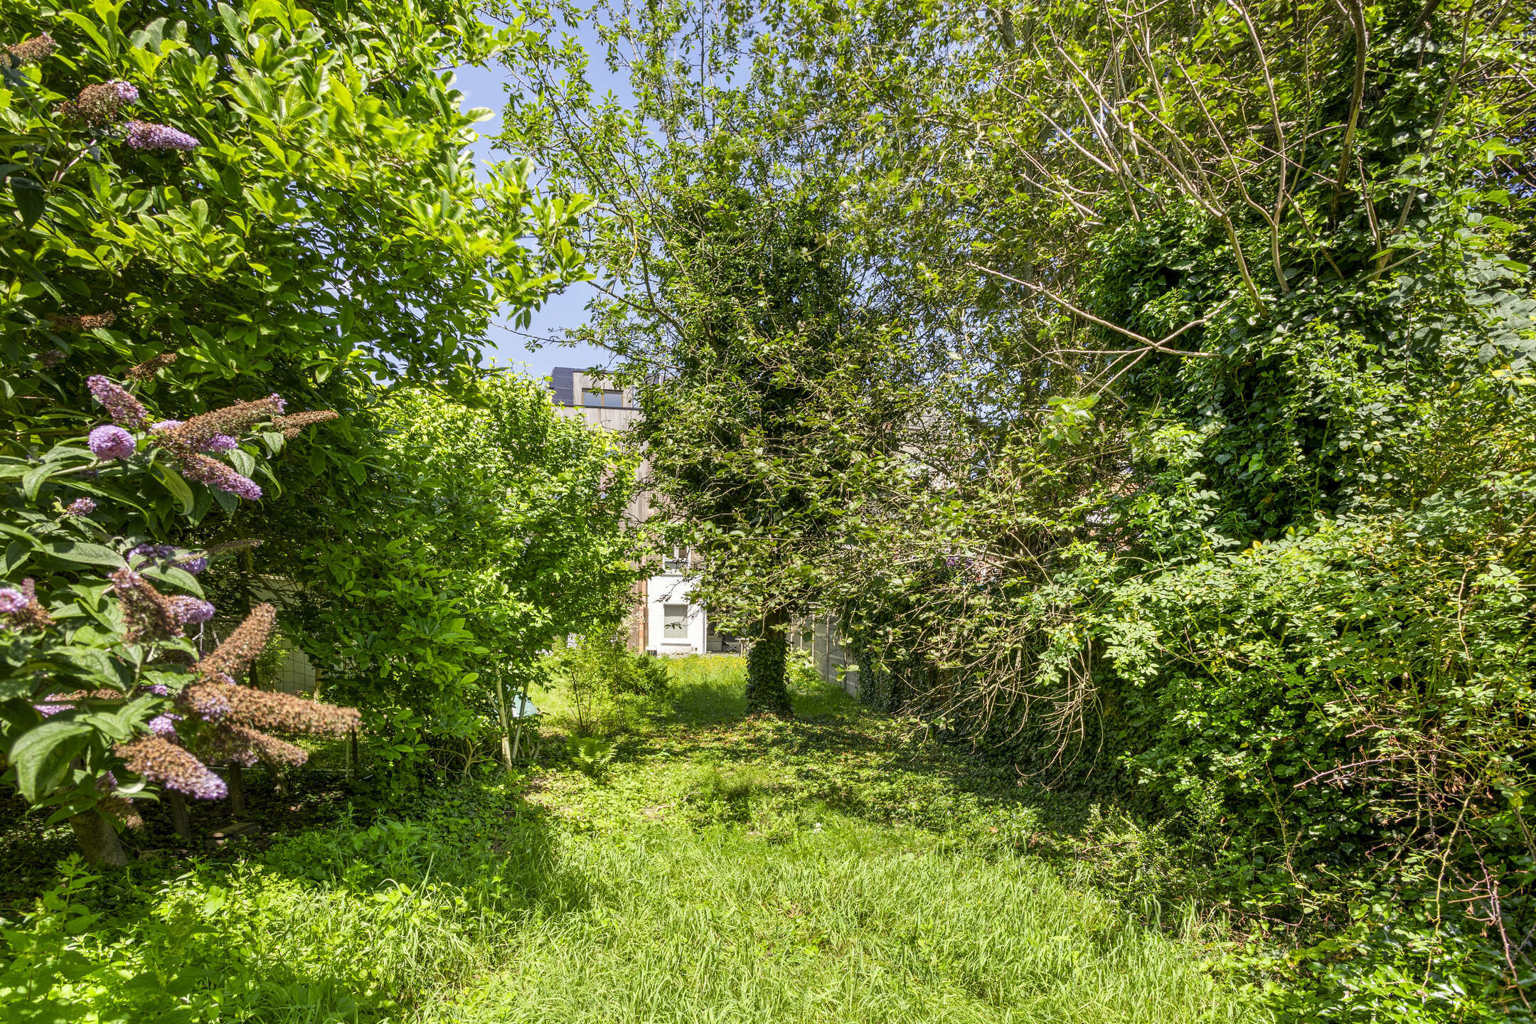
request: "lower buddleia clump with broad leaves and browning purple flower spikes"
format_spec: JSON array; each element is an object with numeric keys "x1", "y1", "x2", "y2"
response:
[{"x1": 0, "y1": 363, "x2": 358, "y2": 863}]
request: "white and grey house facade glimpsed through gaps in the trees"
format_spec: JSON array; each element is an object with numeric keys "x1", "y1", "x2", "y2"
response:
[{"x1": 550, "y1": 367, "x2": 734, "y2": 654}]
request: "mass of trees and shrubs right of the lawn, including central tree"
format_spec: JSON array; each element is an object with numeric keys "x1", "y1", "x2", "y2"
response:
[{"x1": 507, "y1": 0, "x2": 1536, "y2": 1021}]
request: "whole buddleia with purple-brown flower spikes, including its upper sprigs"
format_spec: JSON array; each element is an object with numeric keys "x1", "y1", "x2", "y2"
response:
[{"x1": 0, "y1": 28, "x2": 358, "y2": 863}]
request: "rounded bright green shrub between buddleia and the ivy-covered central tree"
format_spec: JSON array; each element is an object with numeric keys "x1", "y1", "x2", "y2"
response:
[{"x1": 295, "y1": 380, "x2": 634, "y2": 774}]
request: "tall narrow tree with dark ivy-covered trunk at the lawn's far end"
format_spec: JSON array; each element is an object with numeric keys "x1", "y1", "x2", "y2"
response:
[{"x1": 504, "y1": 9, "x2": 908, "y2": 712}]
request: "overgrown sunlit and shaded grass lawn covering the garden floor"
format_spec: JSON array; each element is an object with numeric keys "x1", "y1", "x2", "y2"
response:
[{"x1": 0, "y1": 659, "x2": 1266, "y2": 1024}]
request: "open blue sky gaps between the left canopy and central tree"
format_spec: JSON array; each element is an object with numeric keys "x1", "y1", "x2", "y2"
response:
[{"x1": 453, "y1": 32, "x2": 614, "y2": 376}]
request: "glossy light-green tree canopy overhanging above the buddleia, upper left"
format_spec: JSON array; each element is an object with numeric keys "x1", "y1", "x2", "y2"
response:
[{"x1": 0, "y1": 0, "x2": 570, "y2": 402}]
